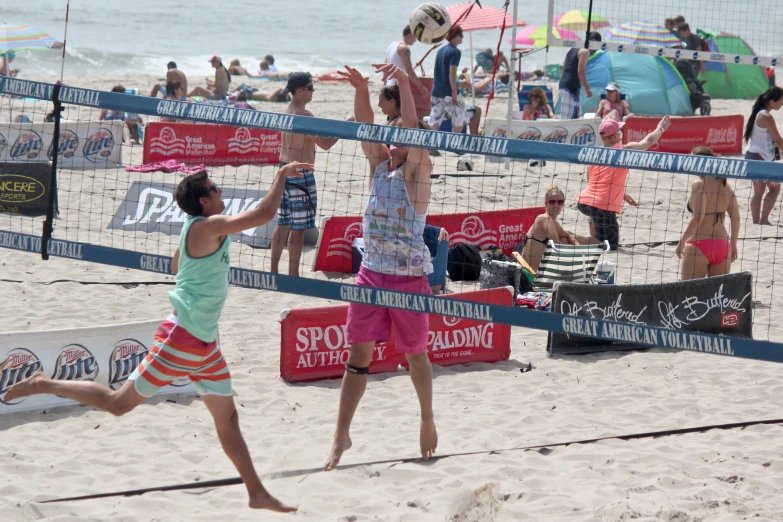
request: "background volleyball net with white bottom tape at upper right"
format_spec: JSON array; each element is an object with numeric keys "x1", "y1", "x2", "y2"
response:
[{"x1": 547, "y1": 0, "x2": 783, "y2": 66}]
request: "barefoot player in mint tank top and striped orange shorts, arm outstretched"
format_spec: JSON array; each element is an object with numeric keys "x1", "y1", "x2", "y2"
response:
[{"x1": 5, "y1": 162, "x2": 313, "y2": 513}]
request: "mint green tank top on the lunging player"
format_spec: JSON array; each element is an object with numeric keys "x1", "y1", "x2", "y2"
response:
[{"x1": 169, "y1": 216, "x2": 231, "y2": 343}]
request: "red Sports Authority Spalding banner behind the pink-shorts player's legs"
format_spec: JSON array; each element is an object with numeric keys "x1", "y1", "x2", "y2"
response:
[{"x1": 280, "y1": 288, "x2": 512, "y2": 382}]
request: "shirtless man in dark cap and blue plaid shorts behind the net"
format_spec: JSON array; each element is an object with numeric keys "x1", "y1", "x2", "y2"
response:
[{"x1": 271, "y1": 72, "x2": 338, "y2": 277}]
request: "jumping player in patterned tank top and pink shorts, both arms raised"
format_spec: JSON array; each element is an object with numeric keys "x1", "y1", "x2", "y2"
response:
[{"x1": 324, "y1": 64, "x2": 438, "y2": 471}]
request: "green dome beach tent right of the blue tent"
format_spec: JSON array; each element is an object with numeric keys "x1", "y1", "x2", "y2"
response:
[{"x1": 699, "y1": 31, "x2": 769, "y2": 100}]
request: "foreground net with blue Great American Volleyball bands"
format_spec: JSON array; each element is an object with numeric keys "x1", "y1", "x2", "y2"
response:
[{"x1": 0, "y1": 78, "x2": 783, "y2": 360}]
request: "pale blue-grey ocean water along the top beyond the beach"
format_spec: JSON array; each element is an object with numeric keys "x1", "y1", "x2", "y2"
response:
[{"x1": 0, "y1": 0, "x2": 783, "y2": 79}]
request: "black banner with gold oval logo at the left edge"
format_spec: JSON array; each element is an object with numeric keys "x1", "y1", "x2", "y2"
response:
[{"x1": 0, "y1": 162, "x2": 57, "y2": 217}]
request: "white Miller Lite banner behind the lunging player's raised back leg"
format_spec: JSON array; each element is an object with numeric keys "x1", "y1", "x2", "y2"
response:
[{"x1": 0, "y1": 321, "x2": 195, "y2": 414}]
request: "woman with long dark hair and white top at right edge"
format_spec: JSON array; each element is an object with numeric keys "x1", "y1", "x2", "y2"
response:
[{"x1": 744, "y1": 87, "x2": 783, "y2": 225}]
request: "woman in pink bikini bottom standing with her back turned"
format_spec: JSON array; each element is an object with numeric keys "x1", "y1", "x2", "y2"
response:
[{"x1": 677, "y1": 147, "x2": 740, "y2": 281}]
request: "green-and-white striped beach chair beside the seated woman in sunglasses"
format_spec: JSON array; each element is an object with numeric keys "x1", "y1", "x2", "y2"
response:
[{"x1": 533, "y1": 240, "x2": 609, "y2": 289}]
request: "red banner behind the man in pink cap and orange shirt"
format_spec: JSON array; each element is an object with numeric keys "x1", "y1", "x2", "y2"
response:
[{"x1": 623, "y1": 115, "x2": 745, "y2": 155}]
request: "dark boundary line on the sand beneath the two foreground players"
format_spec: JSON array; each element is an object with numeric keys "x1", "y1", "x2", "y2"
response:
[{"x1": 41, "y1": 419, "x2": 783, "y2": 504}]
